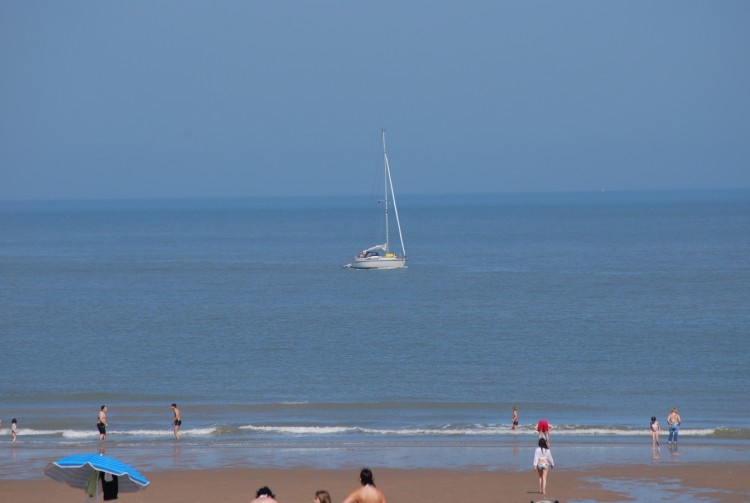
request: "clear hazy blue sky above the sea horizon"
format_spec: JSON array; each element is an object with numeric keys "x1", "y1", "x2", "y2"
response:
[{"x1": 0, "y1": 0, "x2": 750, "y2": 200}]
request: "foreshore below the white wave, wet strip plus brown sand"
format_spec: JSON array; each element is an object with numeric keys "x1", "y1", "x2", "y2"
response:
[{"x1": 0, "y1": 438, "x2": 750, "y2": 503}]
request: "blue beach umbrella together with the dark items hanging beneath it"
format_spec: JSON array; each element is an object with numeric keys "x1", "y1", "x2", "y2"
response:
[{"x1": 44, "y1": 454, "x2": 149, "y2": 500}]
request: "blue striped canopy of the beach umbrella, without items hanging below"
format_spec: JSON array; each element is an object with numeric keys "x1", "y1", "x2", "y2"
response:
[{"x1": 44, "y1": 454, "x2": 149, "y2": 492}]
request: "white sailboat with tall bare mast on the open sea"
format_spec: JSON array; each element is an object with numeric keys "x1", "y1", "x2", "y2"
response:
[{"x1": 345, "y1": 129, "x2": 406, "y2": 269}]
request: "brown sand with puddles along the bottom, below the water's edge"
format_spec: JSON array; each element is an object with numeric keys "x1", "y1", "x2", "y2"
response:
[{"x1": 0, "y1": 463, "x2": 750, "y2": 503}]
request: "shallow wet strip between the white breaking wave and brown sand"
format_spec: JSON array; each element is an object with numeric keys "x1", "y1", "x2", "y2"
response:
[{"x1": 0, "y1": 437, "x2": 750, "y2": 481}]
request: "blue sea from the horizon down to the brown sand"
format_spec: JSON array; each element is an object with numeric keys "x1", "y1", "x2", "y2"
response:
[{"x1": 0, "y1": 189, "x2": 750, "y2": 479}]
